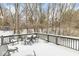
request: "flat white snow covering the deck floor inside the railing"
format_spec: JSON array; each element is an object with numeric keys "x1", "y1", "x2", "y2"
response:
[{"x1": 8, "y1": 39, "x2": 79, "y2": 56}]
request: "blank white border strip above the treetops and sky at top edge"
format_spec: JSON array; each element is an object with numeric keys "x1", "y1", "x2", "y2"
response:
[{"x1": 0, "y1": 0, "x2": 79, "y2": 3}]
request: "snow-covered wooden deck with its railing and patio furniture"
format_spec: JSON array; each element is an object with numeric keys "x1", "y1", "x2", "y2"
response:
[{"x1": 0, "y1": 33, "x2": 79, "y2": 56}]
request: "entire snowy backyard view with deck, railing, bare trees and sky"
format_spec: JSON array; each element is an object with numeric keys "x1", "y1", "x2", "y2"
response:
[{"x1": 0, "y1": 3, "x2": 79, "y2": 56}]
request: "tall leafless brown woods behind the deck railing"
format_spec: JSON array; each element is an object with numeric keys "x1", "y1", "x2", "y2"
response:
[{"x1": 0, "y1": 3, "x2": 79, "y2": 36}]
